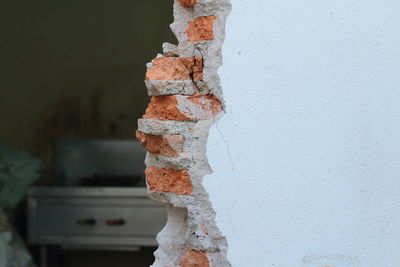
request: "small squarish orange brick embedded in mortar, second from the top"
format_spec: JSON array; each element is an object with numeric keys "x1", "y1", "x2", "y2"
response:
[{"x1": 186, "y1": 16, "x2": 217, "y2": 42}]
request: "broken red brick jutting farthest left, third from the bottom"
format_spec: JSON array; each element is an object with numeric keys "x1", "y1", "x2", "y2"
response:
[{"x1": 136, "y1": 131, "x2": 184, "y2": 157}]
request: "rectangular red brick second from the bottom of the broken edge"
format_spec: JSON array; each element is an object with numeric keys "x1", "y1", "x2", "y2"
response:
[{"x1": 145, "y1": 166, "x2": 193, "y2": 195}]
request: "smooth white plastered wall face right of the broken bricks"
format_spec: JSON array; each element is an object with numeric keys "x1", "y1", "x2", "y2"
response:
[{"x1": 204, "y1": 0, "x2": 400, "y2": 267}]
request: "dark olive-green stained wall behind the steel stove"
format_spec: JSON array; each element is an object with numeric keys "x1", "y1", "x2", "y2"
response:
[{"x1": 0, "y1": 0, "x2": 175, "y2": 174}]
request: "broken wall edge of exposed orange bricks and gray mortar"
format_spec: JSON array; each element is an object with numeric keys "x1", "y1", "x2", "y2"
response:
[{"x1": 136, "y1": 0, "x2": 230, "y2": 267}]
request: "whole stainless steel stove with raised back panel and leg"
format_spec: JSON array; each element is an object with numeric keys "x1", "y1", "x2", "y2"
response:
[{"x1": 28, "y1": 141, "x2": 166, "y2": 266}]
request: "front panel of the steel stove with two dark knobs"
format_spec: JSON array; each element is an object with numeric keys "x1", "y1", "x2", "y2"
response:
[{"x1": 28, "y1": 187, "x2": 166, "y2": 266}]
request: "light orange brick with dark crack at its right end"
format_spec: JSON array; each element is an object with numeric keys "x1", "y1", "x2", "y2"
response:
[{"x1": 146, "y1": 57, "x2": 203, "y2": 80}]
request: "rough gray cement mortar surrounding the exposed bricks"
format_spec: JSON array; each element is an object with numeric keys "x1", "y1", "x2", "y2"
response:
[{"x1": 138, "y1": 0, "x2": 231, "y2": 267}]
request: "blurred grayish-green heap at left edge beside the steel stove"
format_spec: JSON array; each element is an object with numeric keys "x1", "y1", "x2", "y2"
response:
[{"x1": 0, "y1": 142, "x2": 43, "y2": 209}]
